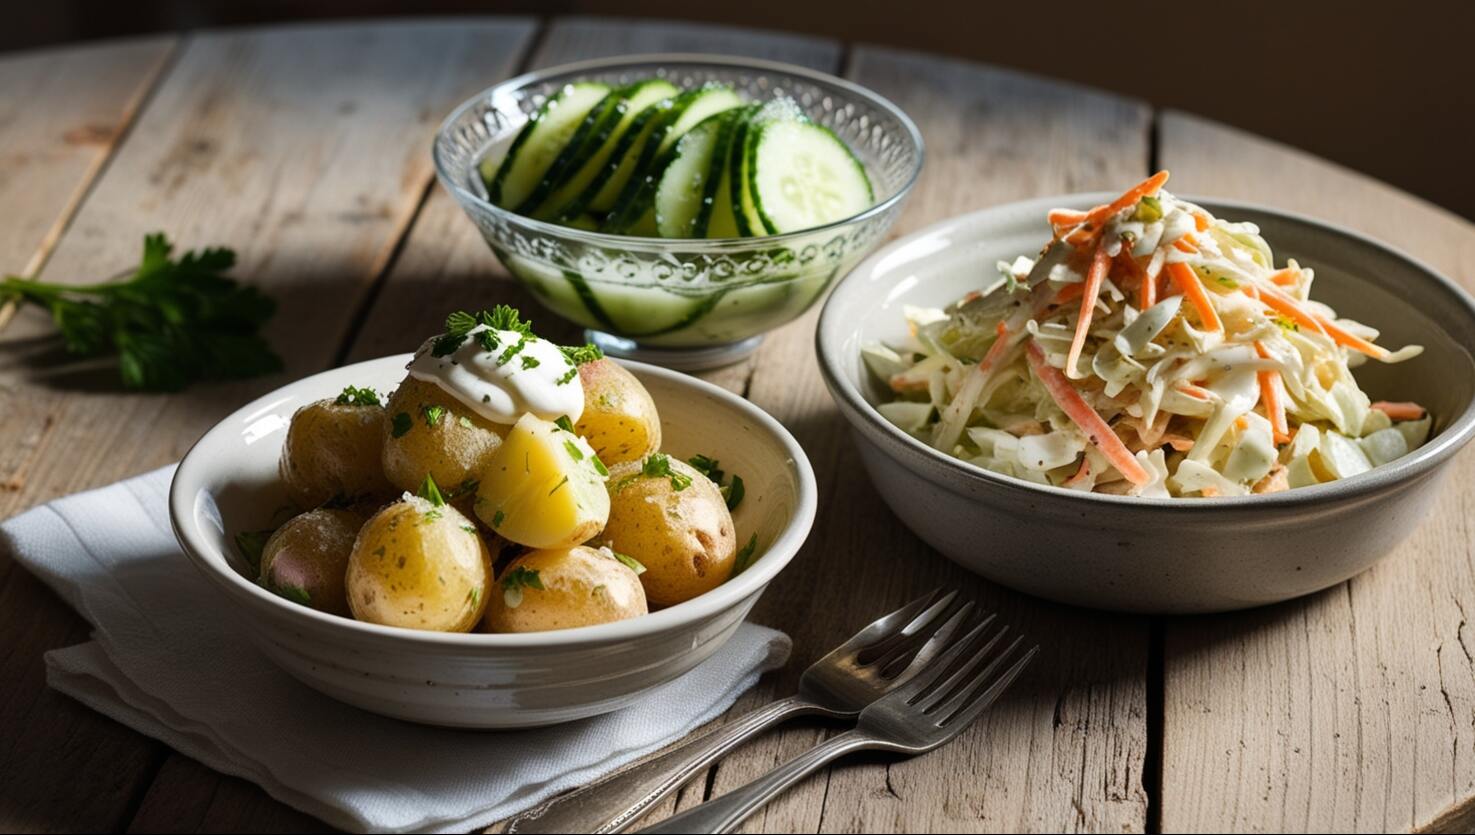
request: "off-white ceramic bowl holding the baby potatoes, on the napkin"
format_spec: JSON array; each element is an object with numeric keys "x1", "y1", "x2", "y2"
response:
[{"x1": 170, "y1": 354, "x2": 816, "y2": 727}]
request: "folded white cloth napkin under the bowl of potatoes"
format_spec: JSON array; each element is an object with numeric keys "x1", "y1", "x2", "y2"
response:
[{"x1": 0, "y1": 468, "x2": 789, "y2": 832}]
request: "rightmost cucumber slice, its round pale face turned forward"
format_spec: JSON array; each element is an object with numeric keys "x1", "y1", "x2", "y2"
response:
[{"x1": 746, "y1": 118, "x2": 875, "y2": 235}]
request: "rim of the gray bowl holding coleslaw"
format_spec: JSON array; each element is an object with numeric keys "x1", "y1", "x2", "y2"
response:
[{"x1": 814, "y1": 192, "x2": 1475, "y2": 513}]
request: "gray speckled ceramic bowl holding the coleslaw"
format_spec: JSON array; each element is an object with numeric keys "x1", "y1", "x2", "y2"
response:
[{"x1": 816, "y1": 193, "x2": 1475, "y2": 612}]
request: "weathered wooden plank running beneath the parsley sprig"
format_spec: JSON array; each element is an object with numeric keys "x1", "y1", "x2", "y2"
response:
[{"x1": 0, "y1": 19, "x2": 532, "y2": 829}]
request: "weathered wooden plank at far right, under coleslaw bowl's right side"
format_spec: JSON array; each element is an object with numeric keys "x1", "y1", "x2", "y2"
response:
[{"x1": 1159, "y1": 112, "x2": 1475, "y2": 832}]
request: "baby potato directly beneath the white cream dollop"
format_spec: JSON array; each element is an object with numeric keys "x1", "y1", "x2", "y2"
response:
[{"x1": 384, "y1": 376, "x2": 509, "y2": 493}]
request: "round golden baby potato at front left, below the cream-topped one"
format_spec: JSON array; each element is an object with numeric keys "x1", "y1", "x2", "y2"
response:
[{"x1": 347, "y1": 496, "x2": 491, "y2": 631}]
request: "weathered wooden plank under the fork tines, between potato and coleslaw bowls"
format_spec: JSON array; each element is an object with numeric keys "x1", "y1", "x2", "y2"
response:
[{"x1": 715, "y1": 47, "x2": 1149, "y2": 832}]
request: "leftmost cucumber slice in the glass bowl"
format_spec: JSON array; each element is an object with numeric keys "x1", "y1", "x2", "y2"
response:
[{"x1": 481, "y1": 83, "x2": 609, "y2": 207}]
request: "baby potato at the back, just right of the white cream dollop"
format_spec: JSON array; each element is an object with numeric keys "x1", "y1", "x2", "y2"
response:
[{"x1": 574, "y1": 358, "x2": 661, "y2": 466}]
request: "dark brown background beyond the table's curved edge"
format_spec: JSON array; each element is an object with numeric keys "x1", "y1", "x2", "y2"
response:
[{"x1": 0, "y1": 0, "x2": 1475, "y2": 218}]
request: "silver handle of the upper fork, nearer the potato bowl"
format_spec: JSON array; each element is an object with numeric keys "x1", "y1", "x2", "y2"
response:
[{"x1": 506, "y1": 696, "x2": 833, "y2": 832}]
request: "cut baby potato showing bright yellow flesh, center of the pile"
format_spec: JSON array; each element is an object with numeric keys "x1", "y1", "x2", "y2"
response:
[{"x1": 476, "y1": 413, "x2": 609, "y2": 549}]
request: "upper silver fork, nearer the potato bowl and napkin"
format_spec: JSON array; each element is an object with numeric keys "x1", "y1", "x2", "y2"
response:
[{"x1": 506, "y1": 589, "x2": 974, "y2": 834}]
